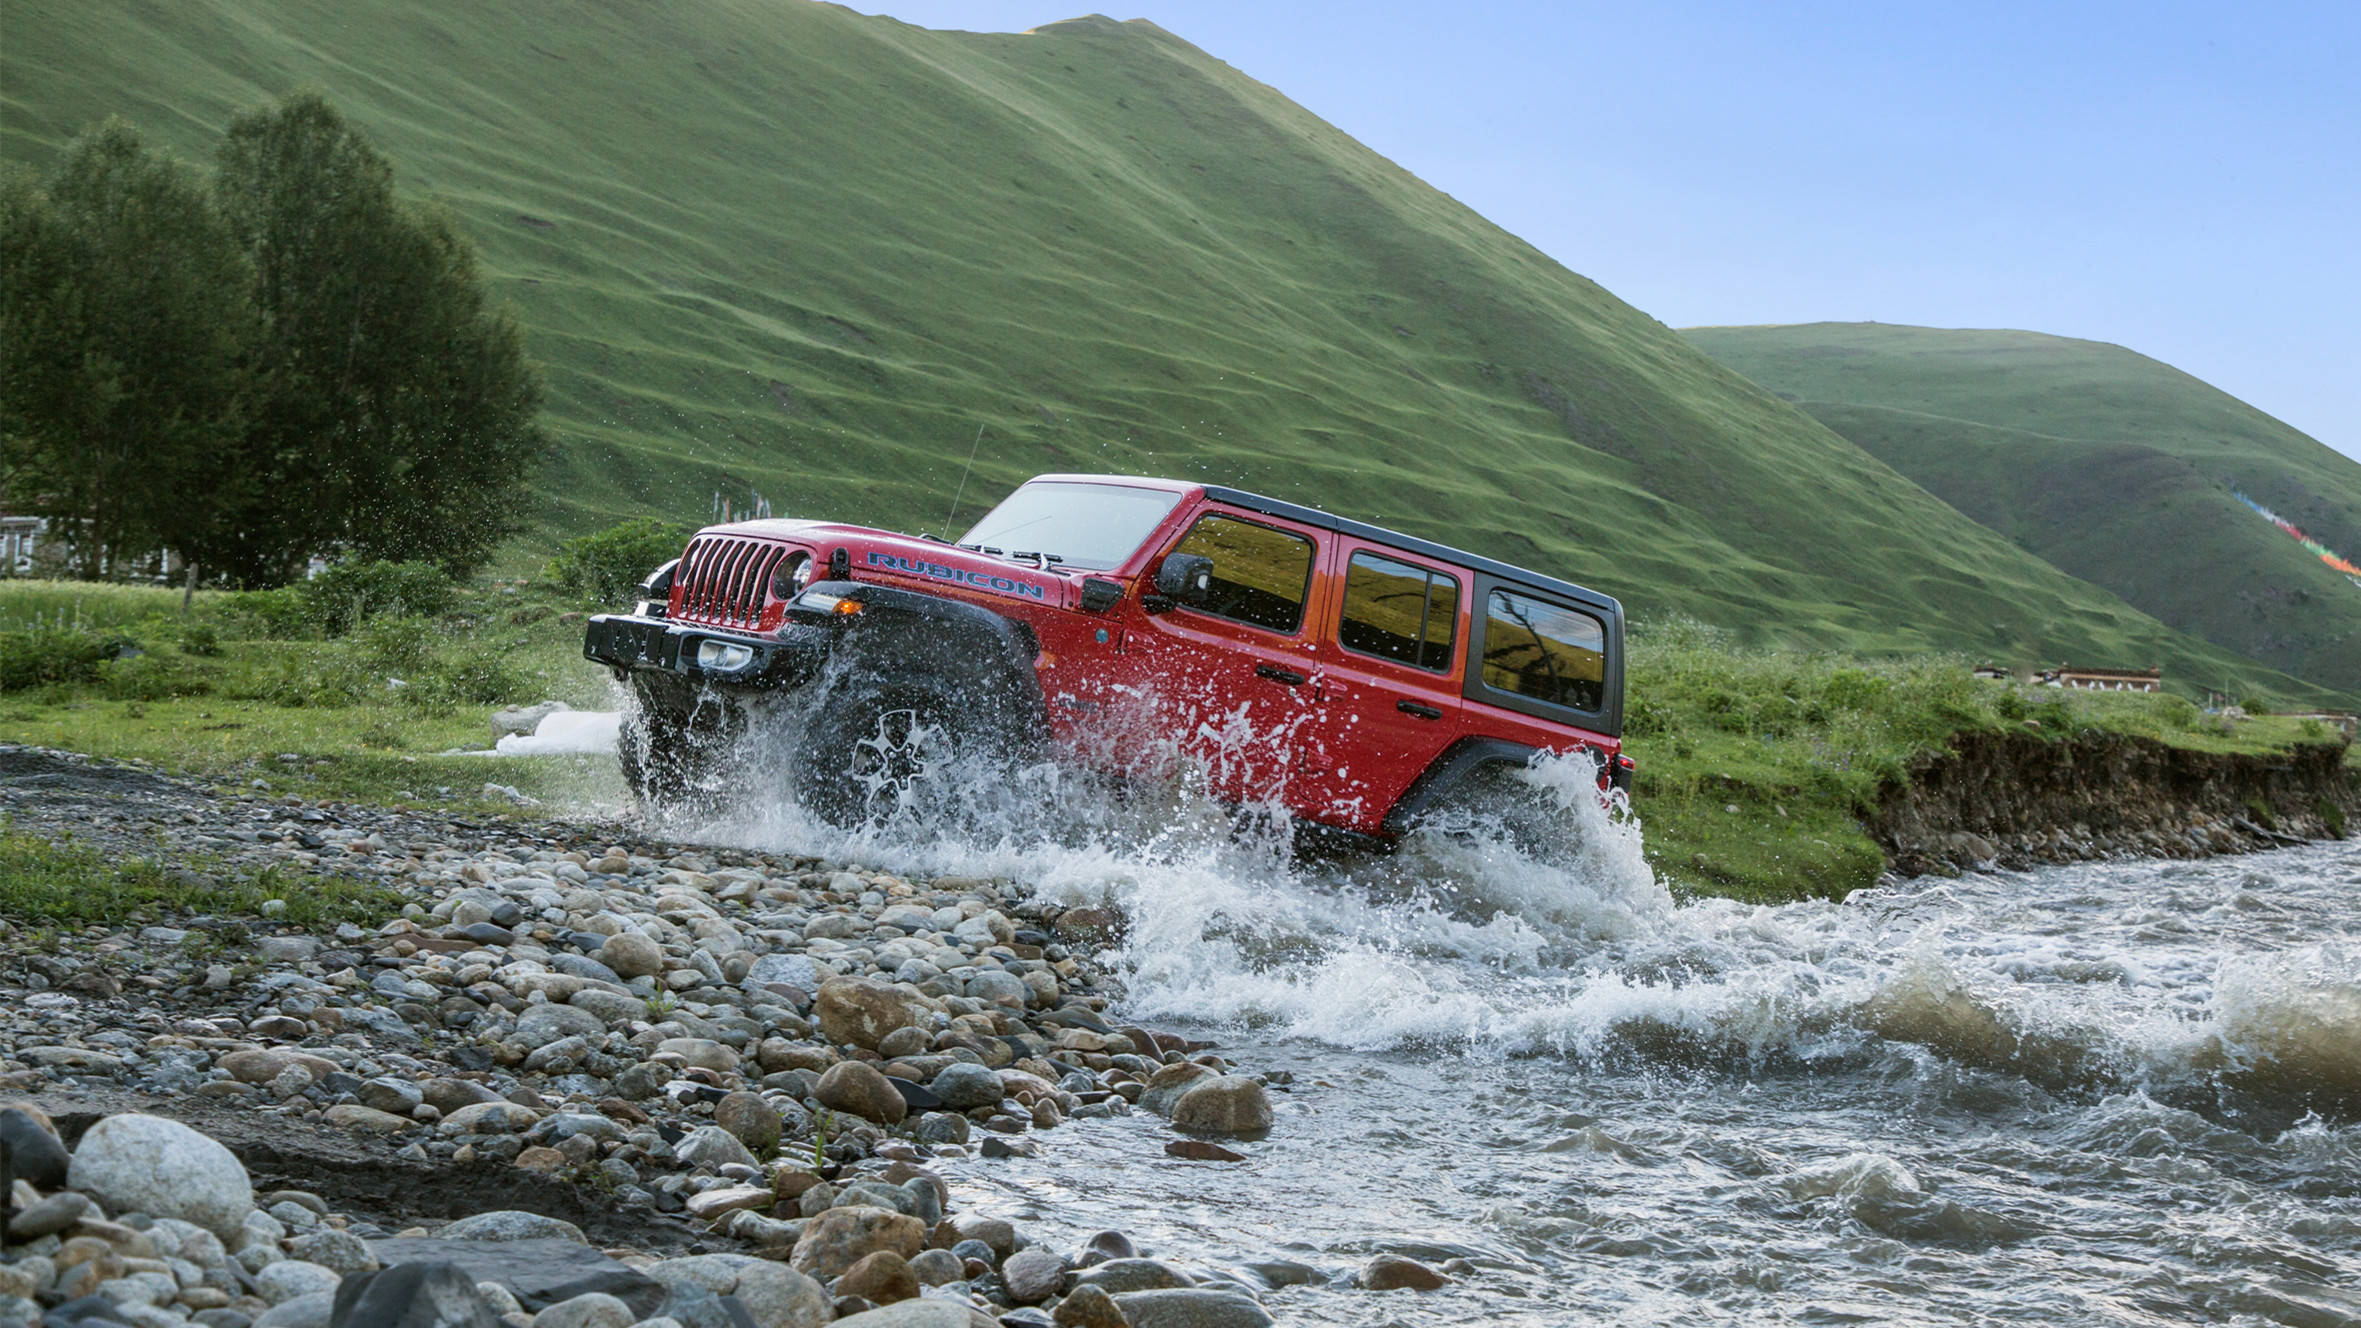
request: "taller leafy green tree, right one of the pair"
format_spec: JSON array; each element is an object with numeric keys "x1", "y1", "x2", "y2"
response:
[{"x1": 215, "y1": 92, "x2": 548, "y2": 581}]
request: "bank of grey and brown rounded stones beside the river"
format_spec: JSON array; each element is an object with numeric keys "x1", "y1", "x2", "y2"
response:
[{"x1": 0, "y1": 747, "x2": 1435, "y2": 1328}]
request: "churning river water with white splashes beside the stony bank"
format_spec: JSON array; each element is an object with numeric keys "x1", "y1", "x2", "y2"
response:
[{"x1": 670, "y1": 751, "x2": 2361, "y2": 1328}]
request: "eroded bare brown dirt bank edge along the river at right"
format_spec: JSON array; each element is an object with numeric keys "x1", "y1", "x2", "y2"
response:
[{"x1": 1868, "y1": 733, "x2": 2361, "y2": 877}]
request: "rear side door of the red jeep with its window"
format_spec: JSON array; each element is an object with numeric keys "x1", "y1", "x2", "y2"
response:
[{"x1": 1299, "y1": 536, "x2": 1469, "y2": 832}]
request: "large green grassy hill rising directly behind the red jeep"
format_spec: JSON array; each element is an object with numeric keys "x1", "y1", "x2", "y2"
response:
[{"x1": 0, "y1": 0, "x2": 2342, "y2": 690}]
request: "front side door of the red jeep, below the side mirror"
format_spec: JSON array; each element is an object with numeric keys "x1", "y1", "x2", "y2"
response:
[{"x1": 1124, "y1": 506, "x2": 1332, "y2": 803}]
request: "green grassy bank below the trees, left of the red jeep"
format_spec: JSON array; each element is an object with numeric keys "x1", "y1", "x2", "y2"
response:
[{"x1": 0, "y1": 581, "x2": 621, "y2": 813}]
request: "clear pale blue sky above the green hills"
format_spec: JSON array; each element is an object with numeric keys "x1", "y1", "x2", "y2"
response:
[{"x1": 855, "y1": 0, "x2": 2361, "y2": 458}]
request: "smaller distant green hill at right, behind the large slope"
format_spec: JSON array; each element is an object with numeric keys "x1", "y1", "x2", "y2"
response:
[{"x1": 1686, "y1": 324, "x2": 2361, "y2": 692}]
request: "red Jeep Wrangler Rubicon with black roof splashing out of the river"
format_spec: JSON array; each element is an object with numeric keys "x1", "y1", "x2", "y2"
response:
[{"x1": 583, "y1": 475, "x2": 1631, "y2": 839}]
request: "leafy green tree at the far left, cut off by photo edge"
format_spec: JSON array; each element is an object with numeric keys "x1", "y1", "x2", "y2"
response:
[{"x1": 0, "y1": 121, "x2": 260, "y2": 577}]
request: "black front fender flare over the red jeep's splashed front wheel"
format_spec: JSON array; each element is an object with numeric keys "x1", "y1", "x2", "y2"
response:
[{"x1": 812, "y1": 581, "x2": 1048, "y2": 740}]
